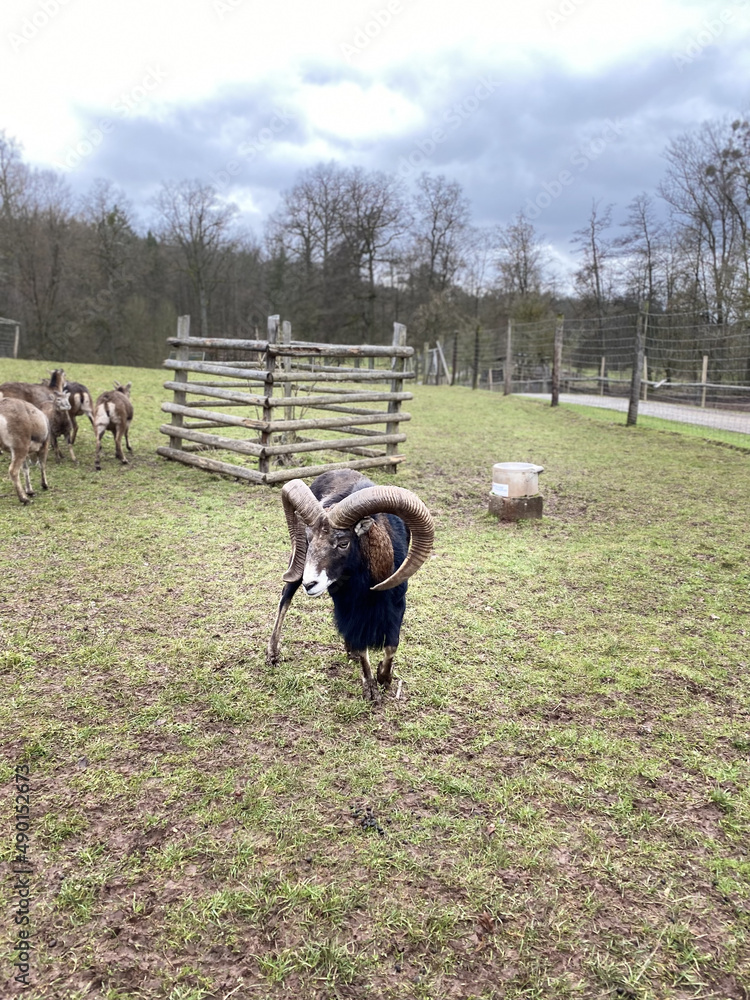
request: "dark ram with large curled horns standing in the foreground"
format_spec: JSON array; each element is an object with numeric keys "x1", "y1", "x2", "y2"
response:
[{"x1": 267, "y1": 469, "x2": 434, "y2": 701}]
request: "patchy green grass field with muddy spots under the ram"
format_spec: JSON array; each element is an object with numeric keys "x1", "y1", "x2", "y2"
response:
[{"x1": 0, "y1": 362, "x2": 750, "y2": 1000}]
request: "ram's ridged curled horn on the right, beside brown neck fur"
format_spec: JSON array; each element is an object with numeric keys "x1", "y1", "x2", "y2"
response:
[{"x1": 328, "y1": 486, "x2": 435, "y2": 590}]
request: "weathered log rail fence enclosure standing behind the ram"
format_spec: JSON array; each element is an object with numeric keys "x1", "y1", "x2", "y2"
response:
[{"x1": 157, "y1": 316, "x2": 414, "y2": 483}]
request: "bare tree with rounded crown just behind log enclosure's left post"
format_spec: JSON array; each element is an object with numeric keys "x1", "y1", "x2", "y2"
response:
[{"x1": 155, "y1": 180, "x2": 239, "y2": 337}]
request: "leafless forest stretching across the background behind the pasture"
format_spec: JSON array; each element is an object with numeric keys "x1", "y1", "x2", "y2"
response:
[{"x1": 0, "y1": 113, "x2": 750, "y2": 366}]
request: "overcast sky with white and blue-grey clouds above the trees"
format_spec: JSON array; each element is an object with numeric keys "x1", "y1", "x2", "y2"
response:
[{"x1": 0, "y1": 0, "x2": 750, "y2": 268}]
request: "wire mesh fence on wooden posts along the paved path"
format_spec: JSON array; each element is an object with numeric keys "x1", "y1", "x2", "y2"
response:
[{"x1": 419, "y1": 313, "x2": 750, "y2": 433}]
